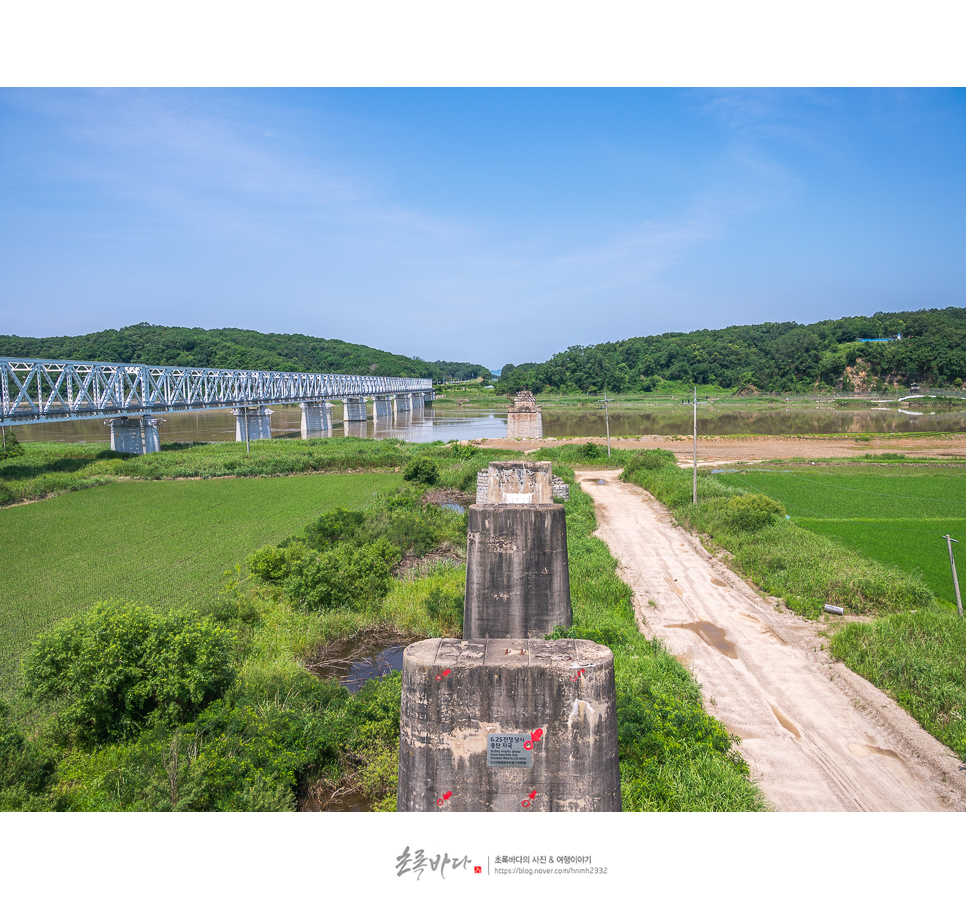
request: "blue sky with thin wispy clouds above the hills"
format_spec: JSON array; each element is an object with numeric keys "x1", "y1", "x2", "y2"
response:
[{"x1": 0, "y1": 88, "x2": 966, "y2": 368}]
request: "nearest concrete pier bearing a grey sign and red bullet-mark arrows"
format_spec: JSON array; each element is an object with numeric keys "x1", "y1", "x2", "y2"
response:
[{"x1": 397, "y1": 639, "x2": 620, "y2": 812}]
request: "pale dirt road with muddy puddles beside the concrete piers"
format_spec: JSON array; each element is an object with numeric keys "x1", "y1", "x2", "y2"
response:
[{"x1": 577, "y1": 470, "x2": 966, "y2": 811}]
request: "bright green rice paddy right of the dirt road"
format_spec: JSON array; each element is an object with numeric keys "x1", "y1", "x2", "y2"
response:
[{"x1": 720, "y1": 463, "x2": 966, "y2": 604}]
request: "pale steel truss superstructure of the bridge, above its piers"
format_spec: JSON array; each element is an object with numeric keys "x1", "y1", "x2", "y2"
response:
[{"x1": 0, "y1": 358, "x2": 433, "y2": 426}]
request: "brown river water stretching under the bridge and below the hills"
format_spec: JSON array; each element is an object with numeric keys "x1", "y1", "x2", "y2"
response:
[{"x1": 13, "y1": 402, "x2": 966, "y2": 443}]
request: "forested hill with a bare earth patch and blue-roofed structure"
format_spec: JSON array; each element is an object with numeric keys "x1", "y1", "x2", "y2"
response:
[{"x1": 497, "y1": 307, "x2": 966, "y2": 393}]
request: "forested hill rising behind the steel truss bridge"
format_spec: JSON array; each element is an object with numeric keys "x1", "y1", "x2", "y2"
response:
[{"x1": 0, "y1": 323, "x2": 490, "y2": 379}]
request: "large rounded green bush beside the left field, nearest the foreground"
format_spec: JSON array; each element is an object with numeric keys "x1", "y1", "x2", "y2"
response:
[{"x1": 23, "y1": 603, "x2": 235, "y2": 743}]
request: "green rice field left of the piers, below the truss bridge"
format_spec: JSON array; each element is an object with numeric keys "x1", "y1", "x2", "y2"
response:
[{"x1": 0, "y1": 473, "x2": 403, "y2": 686}]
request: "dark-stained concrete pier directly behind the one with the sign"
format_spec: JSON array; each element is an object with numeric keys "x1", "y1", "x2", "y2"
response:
[{"x1": 463, "y1": 504, "x2": 573, "y2": 639}]
